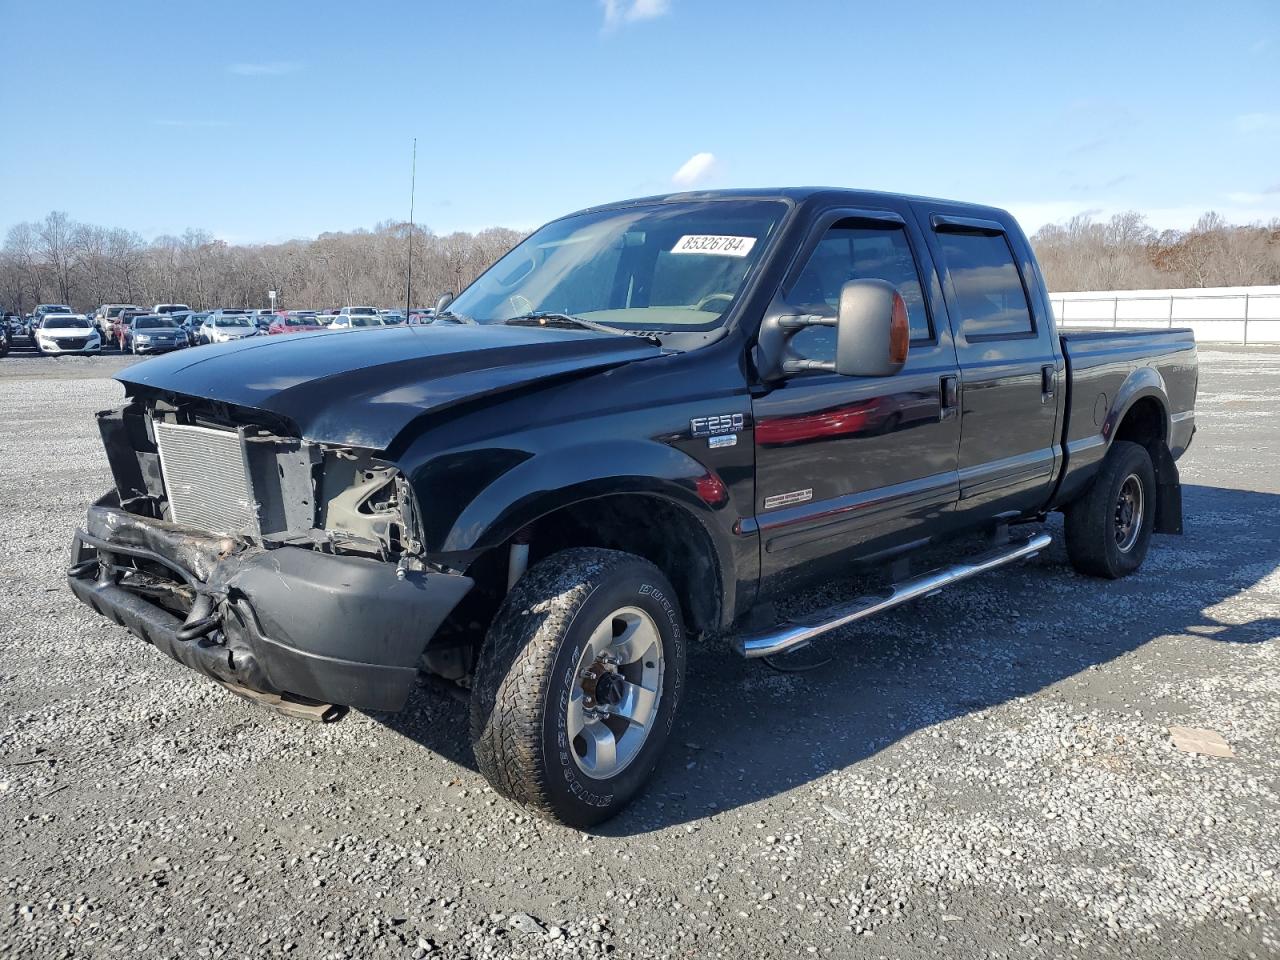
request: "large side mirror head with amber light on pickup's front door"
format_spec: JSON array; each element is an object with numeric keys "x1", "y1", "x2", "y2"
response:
[{"x1": 836, "y1": 280, "x2": 911, "y2": 376}]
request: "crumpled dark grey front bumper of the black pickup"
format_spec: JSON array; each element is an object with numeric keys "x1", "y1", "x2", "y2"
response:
[{"x1": 68, "y1": 498, "x2": 472, "y2": 710}]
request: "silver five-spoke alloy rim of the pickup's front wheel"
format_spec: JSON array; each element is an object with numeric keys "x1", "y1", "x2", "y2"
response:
[{"x1": 568, "y1": 607, "x2": 663, "y2": 780}]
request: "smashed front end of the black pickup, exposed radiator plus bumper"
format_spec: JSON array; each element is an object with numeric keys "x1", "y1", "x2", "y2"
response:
[{"x1": 69, "y1": 396, "x2": 472, "y2": 718}]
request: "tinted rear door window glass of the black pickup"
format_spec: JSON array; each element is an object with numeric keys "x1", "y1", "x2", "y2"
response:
[{"x1": 938, "y1": 230, "x2": 1034, "y2": 339}]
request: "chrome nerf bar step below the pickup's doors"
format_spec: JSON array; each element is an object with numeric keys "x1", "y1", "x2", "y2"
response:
[{"x1": 733, "y1": 534, "x2": 1052, "y2": 657}]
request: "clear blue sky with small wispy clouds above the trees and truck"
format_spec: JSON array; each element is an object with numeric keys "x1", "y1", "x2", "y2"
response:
[{"x1": 0, "y1": 0, "x2": 1280, "y2": 241}]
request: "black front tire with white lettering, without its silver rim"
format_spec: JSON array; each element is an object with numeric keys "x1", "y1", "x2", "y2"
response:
[{"x1": 471, "y1": 548, "x2": 686, "y2": 827}]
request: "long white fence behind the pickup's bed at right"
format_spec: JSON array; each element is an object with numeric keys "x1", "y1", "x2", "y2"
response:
[{"x1": 1050, "y1": 287, "x2": 1280, "y2": 343}]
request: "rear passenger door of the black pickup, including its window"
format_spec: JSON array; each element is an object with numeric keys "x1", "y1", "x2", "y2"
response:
[{"x1": 920, "y1": 205, "x2": 1064, "y2": 525}]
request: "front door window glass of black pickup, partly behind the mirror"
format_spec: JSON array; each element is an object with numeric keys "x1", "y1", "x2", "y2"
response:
[{"x1": 787, "y1": 223, "x2": 933, "y2": 361}]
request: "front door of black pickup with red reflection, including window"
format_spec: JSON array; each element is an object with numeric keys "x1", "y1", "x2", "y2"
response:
[{"x1": 753, "y1": 211, "x2": 960, "y2": 593}]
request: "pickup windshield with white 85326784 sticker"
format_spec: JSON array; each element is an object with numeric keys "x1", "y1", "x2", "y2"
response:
[{"x1": 430, "y1": 200, "x2": 786, "y2": 330}]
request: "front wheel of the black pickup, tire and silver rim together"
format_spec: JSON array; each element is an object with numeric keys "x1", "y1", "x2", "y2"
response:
[{"x1": 471, "y1": 548, "x2": 686, "y2": 827}]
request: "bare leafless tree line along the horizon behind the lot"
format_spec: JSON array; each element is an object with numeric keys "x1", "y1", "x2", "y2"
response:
[{"x1": 0, "y1": 212, "x2": 1280, "y2": 312}]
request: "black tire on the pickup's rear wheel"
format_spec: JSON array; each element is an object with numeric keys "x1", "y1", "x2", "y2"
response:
[{"x1": 1065, "y1": 440, "x2": 1156, "y2": 580}]
